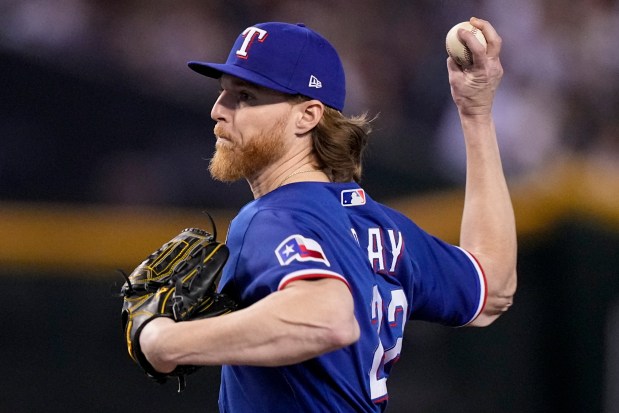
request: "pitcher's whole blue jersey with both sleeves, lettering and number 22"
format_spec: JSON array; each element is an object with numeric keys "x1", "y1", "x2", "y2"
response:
[{"x1": 219, "y1": 182, "x2": 485, "y2": 413}]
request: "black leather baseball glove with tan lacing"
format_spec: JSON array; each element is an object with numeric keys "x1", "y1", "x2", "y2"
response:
[{"x1": 121, "y1": 228, "x2": 237, "y2": 392}]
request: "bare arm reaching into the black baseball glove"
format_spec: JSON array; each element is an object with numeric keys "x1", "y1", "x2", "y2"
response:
[{"x1": 141, "y1": 281, "x2": 358, "y2": 371}]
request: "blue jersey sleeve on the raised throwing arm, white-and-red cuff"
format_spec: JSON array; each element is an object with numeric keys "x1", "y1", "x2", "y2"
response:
[{"x1": 410, "y1": 222, "x2": 486, "y2": 326}]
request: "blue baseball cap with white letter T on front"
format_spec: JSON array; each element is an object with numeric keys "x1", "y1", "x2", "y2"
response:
[{"x1": 188, "y1": 22, "x2": 346, "y2": 111}]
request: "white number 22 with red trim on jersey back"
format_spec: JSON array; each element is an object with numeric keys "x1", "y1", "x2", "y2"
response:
[{"x1": 369, "y1": 285, "x2": 408, "y2": 403}]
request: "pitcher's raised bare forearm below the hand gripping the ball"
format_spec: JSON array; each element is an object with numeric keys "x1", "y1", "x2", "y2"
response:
[{"x1": 460, "y1": 115, "x2": 517, "y2": 325}]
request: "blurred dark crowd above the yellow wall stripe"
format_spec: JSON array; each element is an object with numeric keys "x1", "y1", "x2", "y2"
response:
[{"x1": 0, "y1": 0, "x2": 619, "y2": 206}]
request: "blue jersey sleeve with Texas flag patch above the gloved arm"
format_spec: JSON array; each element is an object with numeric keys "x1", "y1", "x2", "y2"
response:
[{"x1": 224, "y1": 209, "x2": 348, "y2": 303}]
